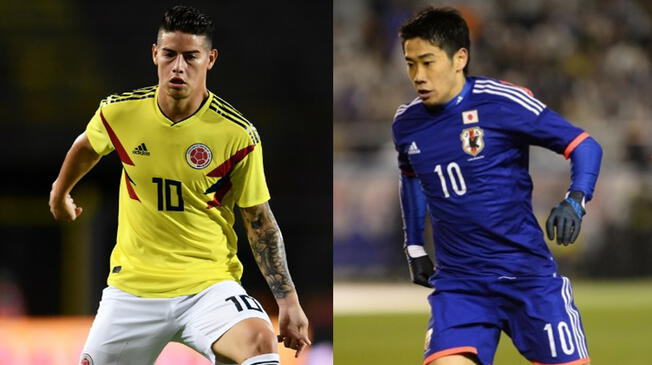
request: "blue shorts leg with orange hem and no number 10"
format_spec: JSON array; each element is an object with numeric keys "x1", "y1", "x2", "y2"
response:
[{"x1": 424, "y1": 279, "x2": 500, "y2": 364}]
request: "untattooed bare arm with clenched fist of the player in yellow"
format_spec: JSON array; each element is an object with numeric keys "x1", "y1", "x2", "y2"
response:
[{"x1": 50, "y1": 133, "x2": 101, "y2": 221}]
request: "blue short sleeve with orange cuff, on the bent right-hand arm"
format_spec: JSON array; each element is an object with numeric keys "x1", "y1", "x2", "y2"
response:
[{"x1": 503, "y1": 104, "x2": 584, "y2": 154}]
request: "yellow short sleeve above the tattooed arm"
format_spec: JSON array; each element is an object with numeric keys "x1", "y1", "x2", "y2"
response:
[{"x1": 232, "y1": 142, "x2": 270, "y2": 208}]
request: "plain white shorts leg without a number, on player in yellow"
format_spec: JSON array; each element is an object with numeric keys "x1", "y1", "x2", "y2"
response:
[{"x1": 81, "y1": 287, "x2": 176, "y2": 365}]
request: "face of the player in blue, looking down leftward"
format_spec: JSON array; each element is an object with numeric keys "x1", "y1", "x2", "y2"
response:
[{"x1": 403, "y1": 37, "x2": 468, "y2": 106}]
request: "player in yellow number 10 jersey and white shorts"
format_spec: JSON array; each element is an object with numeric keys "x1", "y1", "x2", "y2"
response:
[{"x1": 50, "y1": 6, "x2": 310, "y2": 365}]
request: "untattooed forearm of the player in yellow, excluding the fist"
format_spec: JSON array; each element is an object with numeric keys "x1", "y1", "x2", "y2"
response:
[{"x1": 52, "y1": 133, "x2": 101, "y2": 197}]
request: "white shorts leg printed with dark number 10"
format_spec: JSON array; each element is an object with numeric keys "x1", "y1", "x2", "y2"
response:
[{"x1": 175, "y1": 281, "x2": 273, "y2": 363}]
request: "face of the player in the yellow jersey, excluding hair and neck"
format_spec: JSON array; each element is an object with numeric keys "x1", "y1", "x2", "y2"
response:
[{"x1": 152, "y1": 31, "x2": 217, "y2": 99}]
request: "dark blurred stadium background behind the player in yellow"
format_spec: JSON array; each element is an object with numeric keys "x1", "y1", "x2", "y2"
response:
[{"x1": 0, "y1": 0, "x2": 332, "y2": 365}]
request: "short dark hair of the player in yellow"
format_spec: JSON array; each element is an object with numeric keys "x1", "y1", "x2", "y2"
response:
[{"x1": 158, "y1": 5, "x2": 214, "y2": 49}]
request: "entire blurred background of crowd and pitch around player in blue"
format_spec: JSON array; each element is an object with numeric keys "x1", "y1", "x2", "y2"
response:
[{"x1": 333, "y1": 0, "x2": 652, "y2": 365}]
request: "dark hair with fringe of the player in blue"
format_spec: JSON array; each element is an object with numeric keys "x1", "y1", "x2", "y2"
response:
[{"x1": 399, "y1": 6, "x2": 471, "y2": 75}]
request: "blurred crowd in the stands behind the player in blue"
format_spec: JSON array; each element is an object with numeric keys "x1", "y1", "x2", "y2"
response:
[{"x1": 333, "y1": 0, "x2": 652, "y2": 279}]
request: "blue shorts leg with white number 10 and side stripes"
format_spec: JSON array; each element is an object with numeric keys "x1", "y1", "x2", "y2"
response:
[{"x1": 499, "y1": 276, "x2": 589, "y2": 364}]
